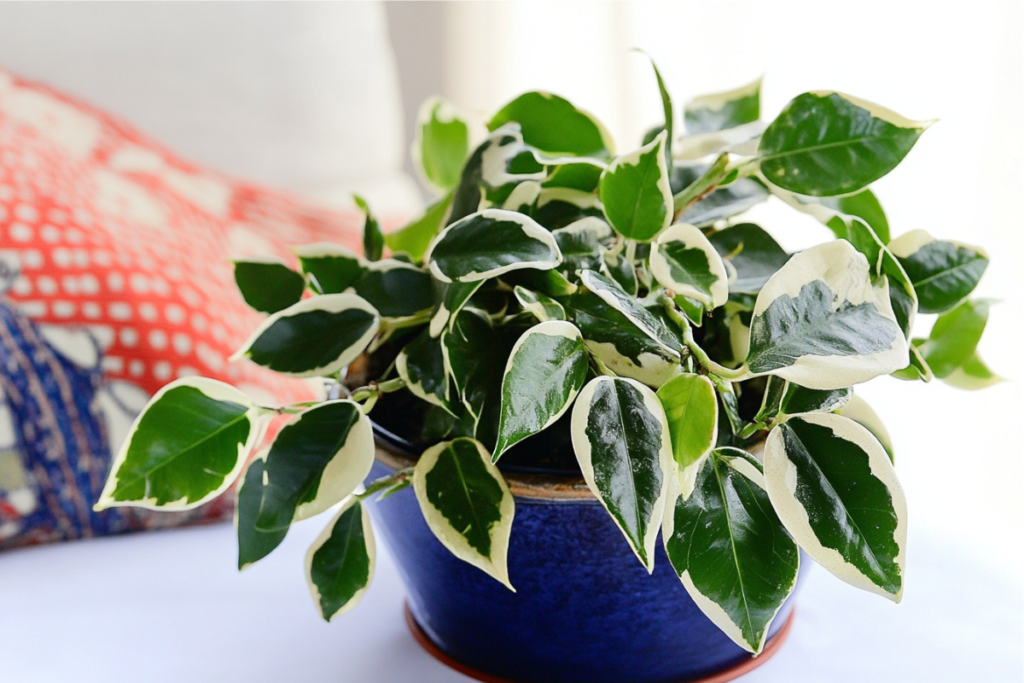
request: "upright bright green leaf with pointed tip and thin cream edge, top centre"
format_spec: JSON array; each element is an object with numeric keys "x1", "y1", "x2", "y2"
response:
[{"x1": 598, "y1": 132, "x2": 673, "y2": 242}]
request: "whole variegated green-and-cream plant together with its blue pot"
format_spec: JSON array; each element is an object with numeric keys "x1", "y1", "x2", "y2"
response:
[{"x1": 96, "y1": 60, "x2": 997, "y2": 682}]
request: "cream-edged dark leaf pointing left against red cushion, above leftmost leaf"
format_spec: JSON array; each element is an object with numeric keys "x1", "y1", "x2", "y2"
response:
[{"x1": 230, "y1": 294, "x2": 380, "y2": 377}]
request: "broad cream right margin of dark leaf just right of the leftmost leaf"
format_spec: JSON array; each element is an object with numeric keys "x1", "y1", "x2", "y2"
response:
[{"x1": 292, "y1": 398, "x2": 375, "y2": 521}]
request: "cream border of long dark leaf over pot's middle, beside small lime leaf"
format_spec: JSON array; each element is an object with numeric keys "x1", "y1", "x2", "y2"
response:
[{"x1": 570, "y1": 376, "x2": 678, "y2": 573}]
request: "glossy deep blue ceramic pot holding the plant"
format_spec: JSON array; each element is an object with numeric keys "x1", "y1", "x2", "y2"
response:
[{"x1": 369, "y1": 430, "x2": 793, "y2": 683}]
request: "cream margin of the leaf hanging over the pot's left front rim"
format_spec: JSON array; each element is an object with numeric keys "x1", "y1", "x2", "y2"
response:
[{"x1": 413, "y1": 439, "x2": 515, "y2": 593}]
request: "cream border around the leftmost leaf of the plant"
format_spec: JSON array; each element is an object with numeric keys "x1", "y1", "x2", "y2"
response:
[{"x1": 92, "y1": 377, "x2": 267, "y2": 512}]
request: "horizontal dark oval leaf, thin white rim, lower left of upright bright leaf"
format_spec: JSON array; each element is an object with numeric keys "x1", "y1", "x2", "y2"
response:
[{"x1": 427, "y1": 209, "x2": 562, "y2": 283}]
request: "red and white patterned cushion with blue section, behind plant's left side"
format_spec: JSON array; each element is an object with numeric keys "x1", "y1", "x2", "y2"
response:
[{"x1": 0, "y1": 70, "x2": 382, "y2": 549}]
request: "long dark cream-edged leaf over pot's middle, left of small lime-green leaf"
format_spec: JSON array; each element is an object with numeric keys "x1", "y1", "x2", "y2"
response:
[{"x1": 571, "y1": 376, "x2": 675, "y2": 573}]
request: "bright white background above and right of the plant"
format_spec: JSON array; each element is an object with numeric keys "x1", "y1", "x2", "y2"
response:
[{"x1": 389, "y1": 0, "x2": 1024, "y2": 573}]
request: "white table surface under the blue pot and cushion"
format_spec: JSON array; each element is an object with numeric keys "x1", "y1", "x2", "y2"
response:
[{"x1": 0, "y1": 518, "x2": 1024, "y2": 683}]
